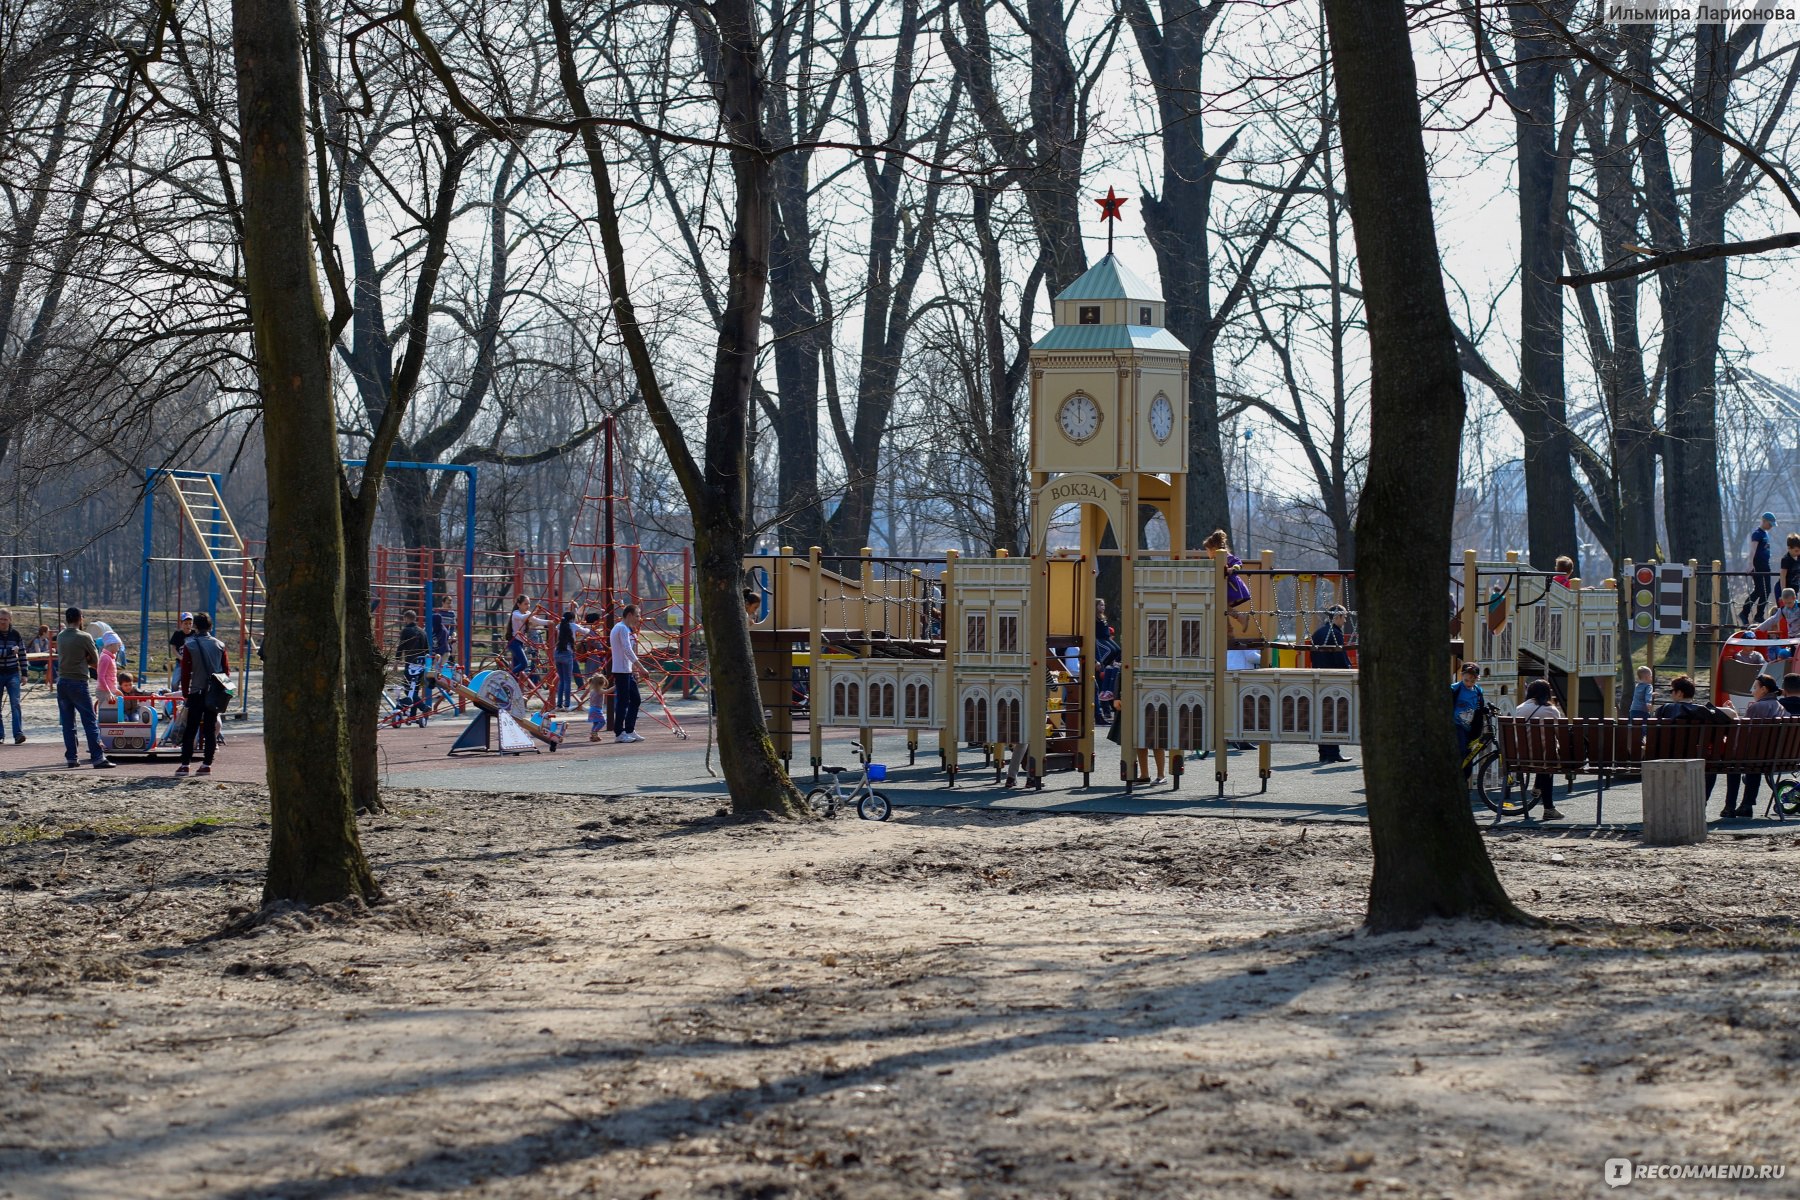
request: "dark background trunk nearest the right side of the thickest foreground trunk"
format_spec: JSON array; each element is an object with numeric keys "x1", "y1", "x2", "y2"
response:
[{"x1": 1510, "y1": 4, "x2": 1580, "y2": 570}]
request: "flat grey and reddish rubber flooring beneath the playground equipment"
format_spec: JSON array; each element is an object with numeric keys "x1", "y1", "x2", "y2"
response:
[{"x1": 17, "y1": 702, "x2": 1800, "y2": 833}]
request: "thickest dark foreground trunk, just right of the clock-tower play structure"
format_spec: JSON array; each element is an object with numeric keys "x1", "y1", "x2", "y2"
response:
[{"x1": 1325, "y1": 0, "x2": 1526, "y2": 930}]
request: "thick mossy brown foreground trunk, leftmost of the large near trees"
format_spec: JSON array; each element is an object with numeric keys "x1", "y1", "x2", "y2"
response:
[{"x1": 232, "y1": 0, "x2": 380, "y2": 903}]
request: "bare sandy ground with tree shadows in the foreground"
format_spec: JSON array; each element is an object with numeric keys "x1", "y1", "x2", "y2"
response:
[{"x1": 0, "y1": 772, "x2": 1800, "y2": 1198}]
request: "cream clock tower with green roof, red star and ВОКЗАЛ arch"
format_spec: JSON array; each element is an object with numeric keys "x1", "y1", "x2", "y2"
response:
[{"x1": 1028, "y1": 210, "x2": 1188, "y2": 779}]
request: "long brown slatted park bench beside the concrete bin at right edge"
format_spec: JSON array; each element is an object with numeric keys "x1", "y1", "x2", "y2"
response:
[{"x1": 1498, "y1": 716, "x2": 1800, "y2": 824}]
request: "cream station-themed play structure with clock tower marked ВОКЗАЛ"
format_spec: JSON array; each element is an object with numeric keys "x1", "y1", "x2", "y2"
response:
[{"x1": 745, "y1": 254, "x2": 1620, "y2": 793}]
